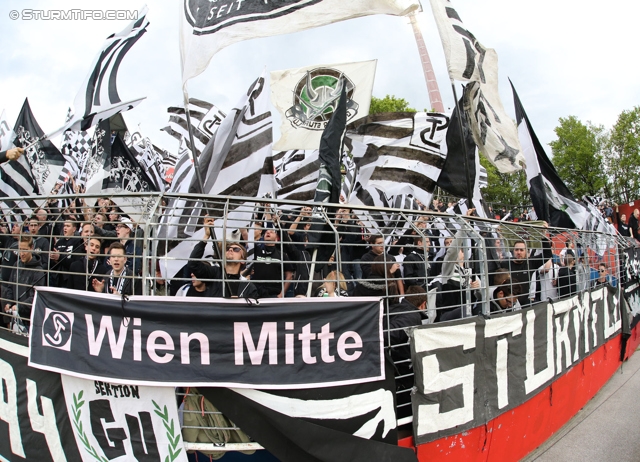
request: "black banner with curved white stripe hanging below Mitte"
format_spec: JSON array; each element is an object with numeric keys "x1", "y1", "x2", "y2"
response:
[{"x1": 198, "y1": 361, "x2": 417, "y2": 462}]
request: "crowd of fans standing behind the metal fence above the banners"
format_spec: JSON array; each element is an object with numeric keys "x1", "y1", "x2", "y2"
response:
[{"x1": 0, "y1": 198, "x2": 616, "y2": 336}]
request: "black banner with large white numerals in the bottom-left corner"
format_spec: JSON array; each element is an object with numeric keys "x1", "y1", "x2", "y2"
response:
[{"x1": 0, "y1": 329, "x2": 82, "y2": 462}]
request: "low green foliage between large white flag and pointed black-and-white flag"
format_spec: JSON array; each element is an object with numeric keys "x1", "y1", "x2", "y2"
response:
[{"x1": 480, "y1": 155, "x2": 531, "y2": 209}]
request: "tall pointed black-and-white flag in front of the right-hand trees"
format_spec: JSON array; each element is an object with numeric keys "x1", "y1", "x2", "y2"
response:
[{"x1": 511, "y1": 83, "x2": 589, "y2": 229}]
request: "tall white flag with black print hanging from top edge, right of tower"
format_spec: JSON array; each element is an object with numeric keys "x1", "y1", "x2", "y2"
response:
[{"x1": 431, "y1": 0, "x2": 524, "y2": 173}]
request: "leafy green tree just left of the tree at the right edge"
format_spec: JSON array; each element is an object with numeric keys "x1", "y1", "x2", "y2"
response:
[{"x1": 549, "y1": 116, "x2": 607, "y2": 199}]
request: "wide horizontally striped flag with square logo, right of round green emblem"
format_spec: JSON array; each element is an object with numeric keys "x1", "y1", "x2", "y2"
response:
[{"x1": 347, "y1": 112, "x2": 449, "y2": 204}]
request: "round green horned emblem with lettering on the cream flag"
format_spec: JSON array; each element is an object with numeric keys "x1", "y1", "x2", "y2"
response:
[{"x1": 285, "y1": 67, "x2": 358, "y2": 130}]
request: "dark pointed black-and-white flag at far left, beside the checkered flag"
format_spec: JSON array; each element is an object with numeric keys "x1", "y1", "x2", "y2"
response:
[{"x1": 13, "y1": 98, "x2": 65, "y2": 195}]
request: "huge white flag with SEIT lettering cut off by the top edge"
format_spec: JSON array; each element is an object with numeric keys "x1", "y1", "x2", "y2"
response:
[{"x1": 180, "y1": 0, "x2": 420, "y2": 86}]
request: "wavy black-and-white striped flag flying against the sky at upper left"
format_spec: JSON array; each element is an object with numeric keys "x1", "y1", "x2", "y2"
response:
[{"x1": 51, "y1": 6, "x2": 149, "y2": 136}]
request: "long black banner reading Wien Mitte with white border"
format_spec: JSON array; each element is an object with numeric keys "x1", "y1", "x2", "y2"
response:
[{"x1": 29, "y1": 288, "x2": 384, "y2": 389}]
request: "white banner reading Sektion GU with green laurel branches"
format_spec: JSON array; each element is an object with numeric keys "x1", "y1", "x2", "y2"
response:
[{"x1": 61, "y1": 375, "x2": 187, "y2": 462}]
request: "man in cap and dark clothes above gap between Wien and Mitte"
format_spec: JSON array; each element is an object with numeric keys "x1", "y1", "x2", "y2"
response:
[{"x1": 187, "y1": 217, "x2": 258, "y2": 298}]
